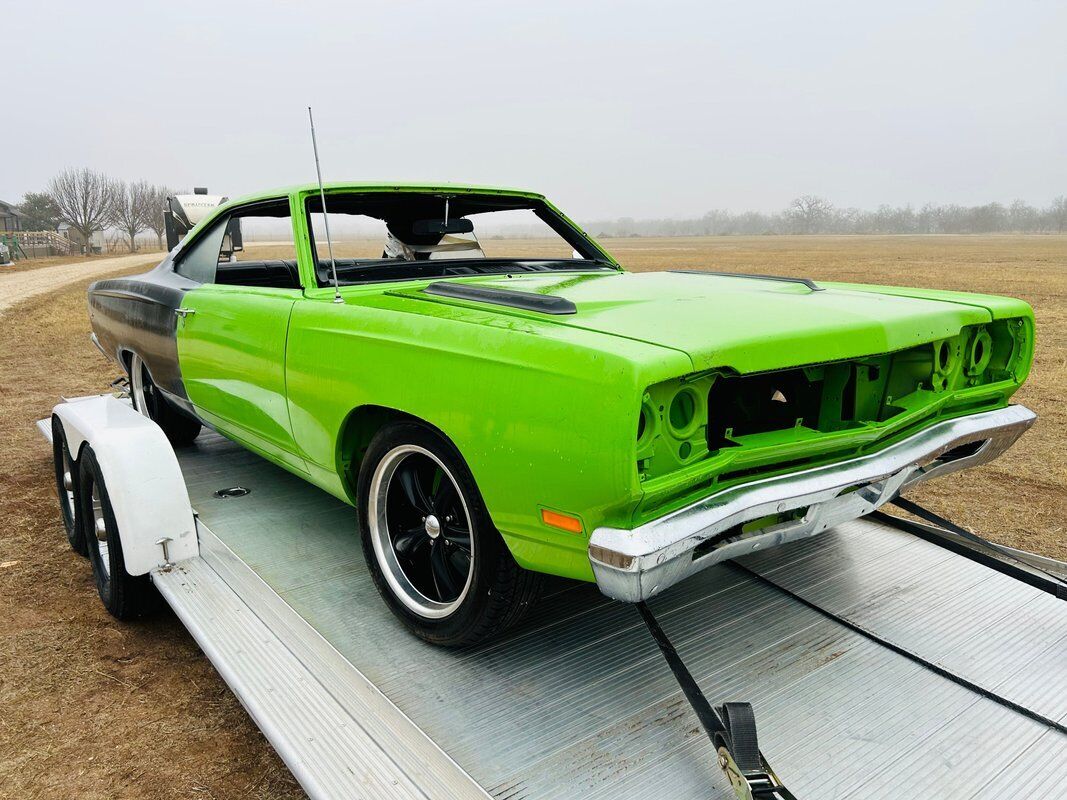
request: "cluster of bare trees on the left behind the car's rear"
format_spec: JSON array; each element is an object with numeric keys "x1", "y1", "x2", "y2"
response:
[{"x1": 17, "y1": 167, "x2": 175, "y2": 253}]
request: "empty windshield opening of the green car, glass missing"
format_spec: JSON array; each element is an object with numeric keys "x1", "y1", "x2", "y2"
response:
[{"x1": 306, "y1": 191, "x2": 611, "y2": 286}]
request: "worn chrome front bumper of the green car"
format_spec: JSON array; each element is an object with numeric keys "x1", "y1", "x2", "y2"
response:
[{"x1": 589, "y1": 405, "x2": 1037, "y2": 603}]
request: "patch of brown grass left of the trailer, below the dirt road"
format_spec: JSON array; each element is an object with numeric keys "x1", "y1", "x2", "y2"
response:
[{"x1": 0, "y1": 268, "x2": 302, "y2": 800}]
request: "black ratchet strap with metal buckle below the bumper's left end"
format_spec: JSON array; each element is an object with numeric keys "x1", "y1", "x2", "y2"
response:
[{"x1": 636, "y1": 603, "x2": 796, "y2": 800}]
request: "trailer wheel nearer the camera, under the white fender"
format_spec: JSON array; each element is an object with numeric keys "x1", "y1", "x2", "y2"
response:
[{"x1": 78, "y1": 447, "x2": 160, "y2": 620}]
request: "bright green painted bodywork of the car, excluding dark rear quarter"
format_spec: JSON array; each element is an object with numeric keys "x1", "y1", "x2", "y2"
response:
[{"x1": 172, "y1": 185, "x2": 1034, "y2": 579}]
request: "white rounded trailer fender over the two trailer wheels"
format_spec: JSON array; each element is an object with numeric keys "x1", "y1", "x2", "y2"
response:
[{"x1": 52, "y1": 395, "x2": 200, "y2": 575}]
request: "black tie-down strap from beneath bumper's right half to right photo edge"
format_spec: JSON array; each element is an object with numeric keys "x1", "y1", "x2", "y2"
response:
[{"x1": 872, "y1": 497, "x2": 1067, "y2": 599}]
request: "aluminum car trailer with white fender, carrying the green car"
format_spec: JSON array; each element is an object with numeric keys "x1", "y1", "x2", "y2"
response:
[{"x1": 39, "y1": 397, "x2": 1067, "y2": 800}]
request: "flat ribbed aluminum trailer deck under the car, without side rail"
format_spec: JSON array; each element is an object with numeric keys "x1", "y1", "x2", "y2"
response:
[{"x1": 170, "y1": 434, "x2": 1067, "y2": 800}]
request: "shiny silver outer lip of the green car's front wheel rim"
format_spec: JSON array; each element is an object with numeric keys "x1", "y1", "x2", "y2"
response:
[{"x1": 367, "y1": 445, "x2": 475, "y2": 620}]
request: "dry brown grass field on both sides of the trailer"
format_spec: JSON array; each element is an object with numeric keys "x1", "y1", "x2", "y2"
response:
[{"x1": 0, "y1": 236, "x2": 1067, "y2": 800}]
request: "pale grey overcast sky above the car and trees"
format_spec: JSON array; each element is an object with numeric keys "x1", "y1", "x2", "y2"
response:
[{"x1": 0, "y1": 0, "x2": 1067, "y2": 220}]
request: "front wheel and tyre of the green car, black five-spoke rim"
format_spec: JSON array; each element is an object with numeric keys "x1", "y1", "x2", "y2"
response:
[{"x1": 357, "y1": 422, "x2": 542, "y2": 646}]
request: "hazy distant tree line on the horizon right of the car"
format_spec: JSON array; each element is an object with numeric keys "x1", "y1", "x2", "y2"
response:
[{"x1": 586, "y1": 194, "x2": 1067, "y2": 237}]
